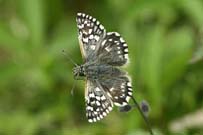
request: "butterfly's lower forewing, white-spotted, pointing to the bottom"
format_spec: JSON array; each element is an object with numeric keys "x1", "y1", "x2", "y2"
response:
[{"x1": 85, "y1": 80, "x2": 113, "y2": 122}]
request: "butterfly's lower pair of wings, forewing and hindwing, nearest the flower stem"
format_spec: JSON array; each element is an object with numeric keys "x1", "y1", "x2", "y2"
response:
[{"x1": 85, "y1": 71, "x2": 132, "y2": 122}]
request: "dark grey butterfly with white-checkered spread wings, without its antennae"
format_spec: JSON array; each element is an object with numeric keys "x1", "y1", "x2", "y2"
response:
[{"x1": 73, "y1": 13, "x2": 133, "y2": 122}]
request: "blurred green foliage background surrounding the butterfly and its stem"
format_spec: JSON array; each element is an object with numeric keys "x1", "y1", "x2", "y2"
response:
[{"x1": 0, "y1": 0, "x2": 203, "y2": 135}]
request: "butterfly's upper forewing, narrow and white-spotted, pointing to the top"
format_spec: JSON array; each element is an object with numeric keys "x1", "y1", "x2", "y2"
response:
[{"x1": 76, "y1": 13, "x2": 106, "y2": 61}]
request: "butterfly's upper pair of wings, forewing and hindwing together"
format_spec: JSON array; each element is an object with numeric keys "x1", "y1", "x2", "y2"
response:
[{"x1": 76, "y1": 13, "x2": 128, "y2": 66}]
